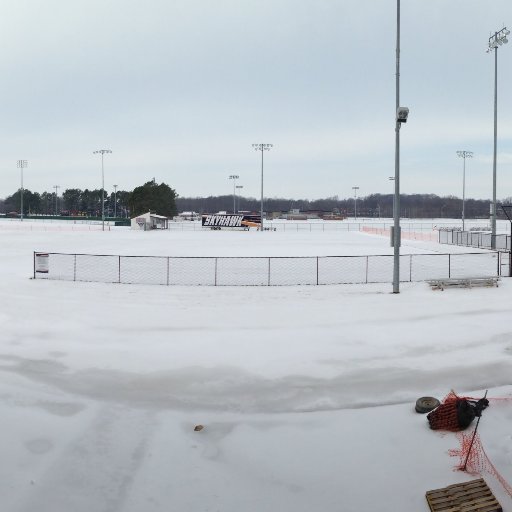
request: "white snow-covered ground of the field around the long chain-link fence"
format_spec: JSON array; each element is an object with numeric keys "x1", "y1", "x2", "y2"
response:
[{"x1": 0, "y1": 222, "x2": 512, "y2": 512}]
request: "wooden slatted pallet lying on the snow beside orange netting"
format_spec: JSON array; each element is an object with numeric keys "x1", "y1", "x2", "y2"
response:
[{"x1": 426, "y1": 478, "x2": 503, "y2": 512}]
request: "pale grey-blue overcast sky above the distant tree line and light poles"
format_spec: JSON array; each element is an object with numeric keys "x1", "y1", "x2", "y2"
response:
[{"x1": 0, "y1": 0, "x2": 512, "y2": 199}]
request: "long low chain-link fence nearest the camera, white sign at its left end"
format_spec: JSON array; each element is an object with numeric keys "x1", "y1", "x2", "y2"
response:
[{"x1": 34, "y1": 252, "x2": 501, "y2": 286}]
